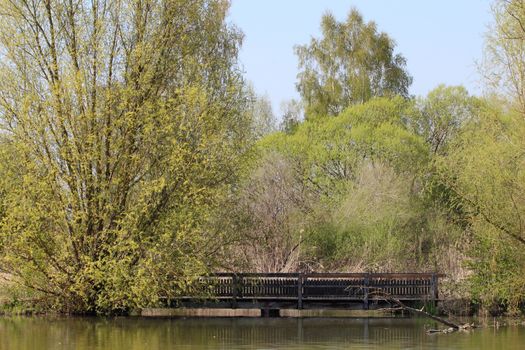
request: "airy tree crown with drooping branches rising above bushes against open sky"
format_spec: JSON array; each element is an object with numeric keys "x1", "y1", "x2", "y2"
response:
[{"x1": 295, "y1": 9, "x2": 412, "y2": 117}]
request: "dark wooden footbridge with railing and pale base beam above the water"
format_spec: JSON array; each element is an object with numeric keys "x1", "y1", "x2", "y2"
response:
[{"x1": 170, "y1": 273, "x2": 444, "y2": 310}]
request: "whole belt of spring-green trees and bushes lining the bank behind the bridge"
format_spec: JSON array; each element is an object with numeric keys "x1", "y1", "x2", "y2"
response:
[{"x1": 0, "y1": 0, "x2": 525, "y2": 313}]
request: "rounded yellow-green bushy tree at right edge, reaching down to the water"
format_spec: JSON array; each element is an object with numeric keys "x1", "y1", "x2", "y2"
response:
[{"x1": 438, "y1": 101, "x2": 525, "y2": 310}]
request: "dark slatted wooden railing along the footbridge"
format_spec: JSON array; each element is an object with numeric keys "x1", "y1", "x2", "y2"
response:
[{"x1": 194, "y1": 273, "x2": 444, "y2": 307}]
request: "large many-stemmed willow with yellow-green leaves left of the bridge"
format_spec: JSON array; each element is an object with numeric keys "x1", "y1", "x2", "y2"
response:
[{"x1": 0, "y1": 0, "x2": 249, "y2": 312}]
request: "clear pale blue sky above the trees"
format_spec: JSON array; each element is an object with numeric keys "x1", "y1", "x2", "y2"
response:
[{"x1": 229, "y1": 0, "x2": 491, "y2": 116}]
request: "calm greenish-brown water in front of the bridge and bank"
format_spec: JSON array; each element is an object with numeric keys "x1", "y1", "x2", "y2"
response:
[{"x1": 0, "y1": 317, "x2": 525, "y2": 350}]
